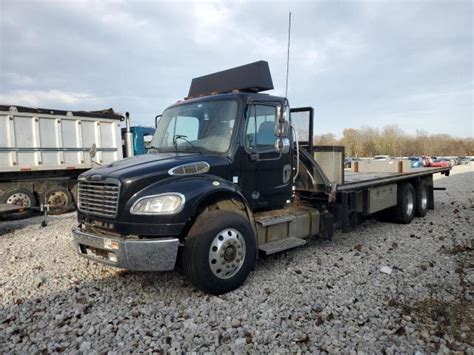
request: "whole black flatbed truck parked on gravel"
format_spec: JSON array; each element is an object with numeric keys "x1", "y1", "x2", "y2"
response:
[{"x1": 73, "y1": 61, "x2": 450, "y2": 294}]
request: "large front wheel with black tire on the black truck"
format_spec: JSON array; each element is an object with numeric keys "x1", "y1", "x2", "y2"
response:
[{"x1": 183, "y1": 210, "x2": 257, "y2": 295}]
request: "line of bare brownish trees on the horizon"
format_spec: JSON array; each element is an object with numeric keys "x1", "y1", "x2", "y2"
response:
[{"x1": 314, "y1": 125, "x2": 474, "y2": 157}]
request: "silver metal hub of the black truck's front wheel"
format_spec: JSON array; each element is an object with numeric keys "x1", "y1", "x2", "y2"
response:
[{"x1": 209, "y1": 228, "x2": 246, "y2": 279}]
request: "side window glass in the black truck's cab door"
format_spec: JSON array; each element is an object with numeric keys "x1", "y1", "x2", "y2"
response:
[{"x1": 245, "y1": 105, "x2": 277, "y2": 149}]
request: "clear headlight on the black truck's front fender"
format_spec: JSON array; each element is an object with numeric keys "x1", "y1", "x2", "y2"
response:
[{"x1": 130, "y1": 192, "x2": 185, "y2": 215}]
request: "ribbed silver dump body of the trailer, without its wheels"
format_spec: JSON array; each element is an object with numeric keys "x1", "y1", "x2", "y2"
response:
[{"x1": 0, "y1": 106, "x2": 122, "y2": 172}]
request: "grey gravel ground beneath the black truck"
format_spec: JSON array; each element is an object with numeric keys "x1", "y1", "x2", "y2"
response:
[{"x1": 0, "y1": 167, "x2": 474, "y2": 354}]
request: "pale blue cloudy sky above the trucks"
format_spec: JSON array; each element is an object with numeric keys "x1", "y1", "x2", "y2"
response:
[{"x1": 0, "y1": 0, "x2": 474, "y2": 137}]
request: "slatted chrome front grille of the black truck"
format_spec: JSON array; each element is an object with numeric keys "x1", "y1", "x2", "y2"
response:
[{"x1": 77, "y1": 180, "x2": 120, "y2": 217}]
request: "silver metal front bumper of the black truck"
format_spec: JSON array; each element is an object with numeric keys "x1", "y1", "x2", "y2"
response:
[{"x1": 72, "y1": 228, "x2": 179, "y2": 271}]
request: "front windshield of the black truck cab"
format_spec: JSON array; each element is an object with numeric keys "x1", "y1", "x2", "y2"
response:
[{"x1": 151, "y1": 100, "x2": 237, "y2": 153}]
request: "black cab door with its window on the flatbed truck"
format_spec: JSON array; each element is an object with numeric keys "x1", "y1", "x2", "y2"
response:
[{"x1": 243, "y1": 103, "x2": 292, "y2": 209}]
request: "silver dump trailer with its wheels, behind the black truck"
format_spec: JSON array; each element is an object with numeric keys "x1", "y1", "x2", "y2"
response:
[{"x1": 0, "y1": 105, "x2": 124, "y2": 213}]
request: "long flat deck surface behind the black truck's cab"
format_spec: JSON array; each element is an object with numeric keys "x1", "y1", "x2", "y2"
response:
[{"x1": 336, "y1": 167, "x2": 451, "y2": 191}]
